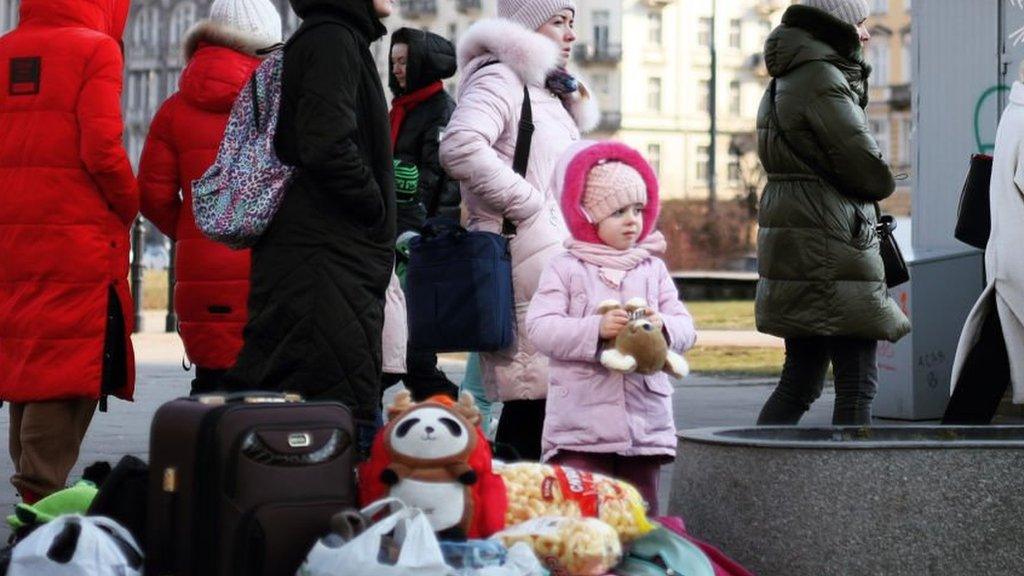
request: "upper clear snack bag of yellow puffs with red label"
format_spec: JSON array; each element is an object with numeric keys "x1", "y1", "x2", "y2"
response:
[{"x1": 495, "y1": 462, "x2": 654, "y2": 544}]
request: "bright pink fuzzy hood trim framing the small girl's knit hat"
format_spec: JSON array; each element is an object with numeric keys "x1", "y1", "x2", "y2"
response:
[{"x1": 552, "y1": 140, "x2": 662, "y2": 244}]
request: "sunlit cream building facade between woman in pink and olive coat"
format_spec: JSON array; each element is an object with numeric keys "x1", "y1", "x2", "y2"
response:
[{"x1": 617, "y1": 0, "x2": 787, "y2": 199}]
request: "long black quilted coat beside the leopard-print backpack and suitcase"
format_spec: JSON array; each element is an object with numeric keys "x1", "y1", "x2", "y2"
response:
[{"x1": 227, "y1": 0, "x2": 395, "y2": 418}]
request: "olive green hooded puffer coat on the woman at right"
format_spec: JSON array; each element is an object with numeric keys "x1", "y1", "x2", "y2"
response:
[{"x1": 757, "y1": 5, "x2": 910, "y2": 341}]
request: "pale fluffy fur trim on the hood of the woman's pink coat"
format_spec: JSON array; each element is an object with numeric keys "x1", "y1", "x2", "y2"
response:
[{"x1": 458, "y1": 18, "x2": 601, "y2": 132}]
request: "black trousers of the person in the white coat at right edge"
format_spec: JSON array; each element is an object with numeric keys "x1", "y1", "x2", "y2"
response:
[{"x1": 942, "y1": 310, "x2": 1010, "y2": 424}]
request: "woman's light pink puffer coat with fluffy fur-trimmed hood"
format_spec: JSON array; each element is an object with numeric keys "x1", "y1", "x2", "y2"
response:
[{"x1": 440, "y1": 19, "x2": 599, "y2": 401}]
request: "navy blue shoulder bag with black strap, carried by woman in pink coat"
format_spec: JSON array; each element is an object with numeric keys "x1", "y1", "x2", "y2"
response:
[{"x1": 406, "y1": 79, "x2": 534, "y2": 353}]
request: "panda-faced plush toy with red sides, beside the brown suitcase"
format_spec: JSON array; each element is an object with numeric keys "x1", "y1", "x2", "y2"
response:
[{"x1": 359, "y1": 392, "x2": 507, "y2": 540}]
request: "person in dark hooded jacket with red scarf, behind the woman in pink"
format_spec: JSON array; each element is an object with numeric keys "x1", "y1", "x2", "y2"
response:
[{"x1": 383, "y1": 28, "x2": 461, "y2": 401}]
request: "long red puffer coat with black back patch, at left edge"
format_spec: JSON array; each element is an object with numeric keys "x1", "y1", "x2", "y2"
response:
[{"x1": 0, "y1": 0, "x2": 138, "y2": 402}]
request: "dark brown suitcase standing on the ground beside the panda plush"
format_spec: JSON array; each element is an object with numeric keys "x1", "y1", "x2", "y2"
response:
[{"x1": 145, "y1": 393, "x2": 356, "y2": 576}]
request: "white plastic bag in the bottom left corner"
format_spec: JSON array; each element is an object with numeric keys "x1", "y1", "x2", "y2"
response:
[{"x1": 7, "y1": 515, "x2": 142, "y2": 576}]
